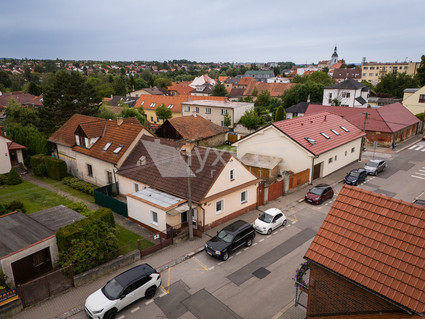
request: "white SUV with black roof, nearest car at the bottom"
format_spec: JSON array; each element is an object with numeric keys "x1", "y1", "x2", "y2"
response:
[{"x1": 84, "y1": 264, "x2": 161, "y2": 319}]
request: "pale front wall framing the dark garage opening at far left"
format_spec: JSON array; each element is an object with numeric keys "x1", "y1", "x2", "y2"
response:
[{"x1": 0, "y1": 236, "x2": 59, "y2": 287}]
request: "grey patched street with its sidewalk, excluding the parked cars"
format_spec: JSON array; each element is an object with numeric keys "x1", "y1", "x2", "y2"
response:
[{"x1": 10, "y1": 137, "x2": 425, "y2": 319}]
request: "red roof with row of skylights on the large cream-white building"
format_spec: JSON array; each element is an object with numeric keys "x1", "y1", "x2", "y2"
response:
[{"x1": 272, "y1": 112, "x2": 365, "y2": 155}]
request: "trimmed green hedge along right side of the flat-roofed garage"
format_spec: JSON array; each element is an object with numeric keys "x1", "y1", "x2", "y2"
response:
[{"x1": 56, "y1": 208, "x2": 115, "y2": 252}]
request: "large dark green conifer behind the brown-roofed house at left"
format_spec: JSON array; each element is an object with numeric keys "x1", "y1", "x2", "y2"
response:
[{"x1": 38, "y1": 70, "x2": 101, "y2": 133}]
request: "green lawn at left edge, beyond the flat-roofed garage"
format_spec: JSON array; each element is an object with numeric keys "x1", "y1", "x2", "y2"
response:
[{"x1": 0, "y1": 181, "x2": 71, "y2": 214}]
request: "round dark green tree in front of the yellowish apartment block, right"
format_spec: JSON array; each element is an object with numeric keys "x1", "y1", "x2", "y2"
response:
[{"x1": 375, "y1": 72, "x2": 418, "y2": 98}]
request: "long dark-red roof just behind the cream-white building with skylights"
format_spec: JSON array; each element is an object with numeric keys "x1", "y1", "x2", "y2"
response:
[{"x1": 305, "y1": 103, "x2": 419, "y2": 133}]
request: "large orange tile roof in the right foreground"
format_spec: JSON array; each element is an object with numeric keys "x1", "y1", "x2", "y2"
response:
[{"x1": 305, "y1": 185, "x2": 425, "y2": 314}]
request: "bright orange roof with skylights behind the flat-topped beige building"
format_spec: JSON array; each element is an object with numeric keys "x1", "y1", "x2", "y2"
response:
[{"x1": 134, "y1": 94, "x2": 227, "y2": 113}]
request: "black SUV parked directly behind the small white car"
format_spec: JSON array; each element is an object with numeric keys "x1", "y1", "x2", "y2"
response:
[{"x1": 205, "y1": 220, "x2": 255, "y2": 261}]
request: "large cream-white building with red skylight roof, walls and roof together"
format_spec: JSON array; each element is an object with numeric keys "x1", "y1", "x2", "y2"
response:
[{"x1": 233, "y1": 112, "x2": 364, "y2": 183}]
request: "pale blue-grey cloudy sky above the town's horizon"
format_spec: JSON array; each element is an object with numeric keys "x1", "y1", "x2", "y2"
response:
[{"x1": 0, "y1": 0, "x2": 425, "y2": 64}]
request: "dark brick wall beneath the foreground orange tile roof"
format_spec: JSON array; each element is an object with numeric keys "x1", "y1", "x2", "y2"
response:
[{"x1": 307, "y1": 264, "x2": 400, "y2": 318}]
